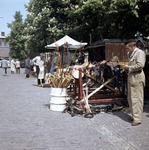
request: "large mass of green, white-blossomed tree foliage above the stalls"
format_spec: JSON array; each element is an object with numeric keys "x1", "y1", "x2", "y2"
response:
[{"x1": 23, "y1": 0, "x2": 149, "y2": 53}]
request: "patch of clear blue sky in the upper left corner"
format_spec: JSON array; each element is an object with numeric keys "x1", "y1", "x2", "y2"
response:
[{"x1": 0, "y1": 0, "x2": 30, "y2": 36}]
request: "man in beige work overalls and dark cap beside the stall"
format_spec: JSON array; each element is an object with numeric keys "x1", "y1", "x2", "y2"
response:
[{"x1": 121, "y1": 40, "x2": 146, "y2": 126}]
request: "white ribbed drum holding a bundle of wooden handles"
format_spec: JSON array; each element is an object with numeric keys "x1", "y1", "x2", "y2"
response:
[{"x1": 50, "y1": 88, "x2": 67, "y2": 111}]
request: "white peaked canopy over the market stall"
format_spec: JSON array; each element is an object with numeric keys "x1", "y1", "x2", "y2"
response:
[{"x1": 45, "y1": 35, "x2": 87, "y2": 49}]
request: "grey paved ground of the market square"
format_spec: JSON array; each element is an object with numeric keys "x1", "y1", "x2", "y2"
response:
[{"x1": 0, "y1": 68, "x2": 149, "y2": 150}]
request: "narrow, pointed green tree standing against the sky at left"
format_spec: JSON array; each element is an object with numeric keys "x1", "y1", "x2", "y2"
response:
[{"x1": 6, "y1": 11, "x2": 26, "y2": 60}]
